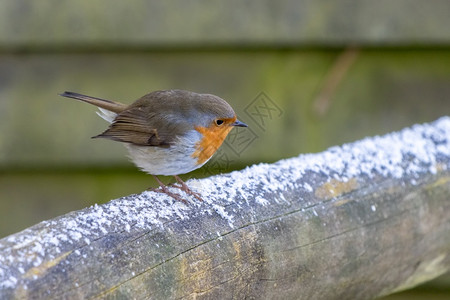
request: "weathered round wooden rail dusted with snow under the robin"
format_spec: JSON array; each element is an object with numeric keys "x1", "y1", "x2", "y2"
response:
[{"x1": 0, "y1": 117, "x2": 450, "y2": 299}]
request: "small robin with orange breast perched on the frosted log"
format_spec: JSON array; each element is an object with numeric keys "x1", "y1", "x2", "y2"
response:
[{"x1": 61, "y1": 90, "x2": 247, "y2": 202}]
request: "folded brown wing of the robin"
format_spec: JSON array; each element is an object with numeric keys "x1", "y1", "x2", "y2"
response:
[{"x1": 94, "y1": 107, "x2": 186, "y2": 147}]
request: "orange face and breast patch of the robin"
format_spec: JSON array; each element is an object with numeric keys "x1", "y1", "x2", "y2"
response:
[{"x1": 192, "y1": 118, "x2": 236, "y2": 165}]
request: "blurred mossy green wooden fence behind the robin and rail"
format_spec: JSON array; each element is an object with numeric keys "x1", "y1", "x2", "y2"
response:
[{"x1": 0, "y1": 0, "x2": 450, "y2": 299}]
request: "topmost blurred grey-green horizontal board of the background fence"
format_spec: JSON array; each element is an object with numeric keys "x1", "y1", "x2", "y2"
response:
[{"x1": 0, "y1": 0, "x2": 450, "y2": 50}]
